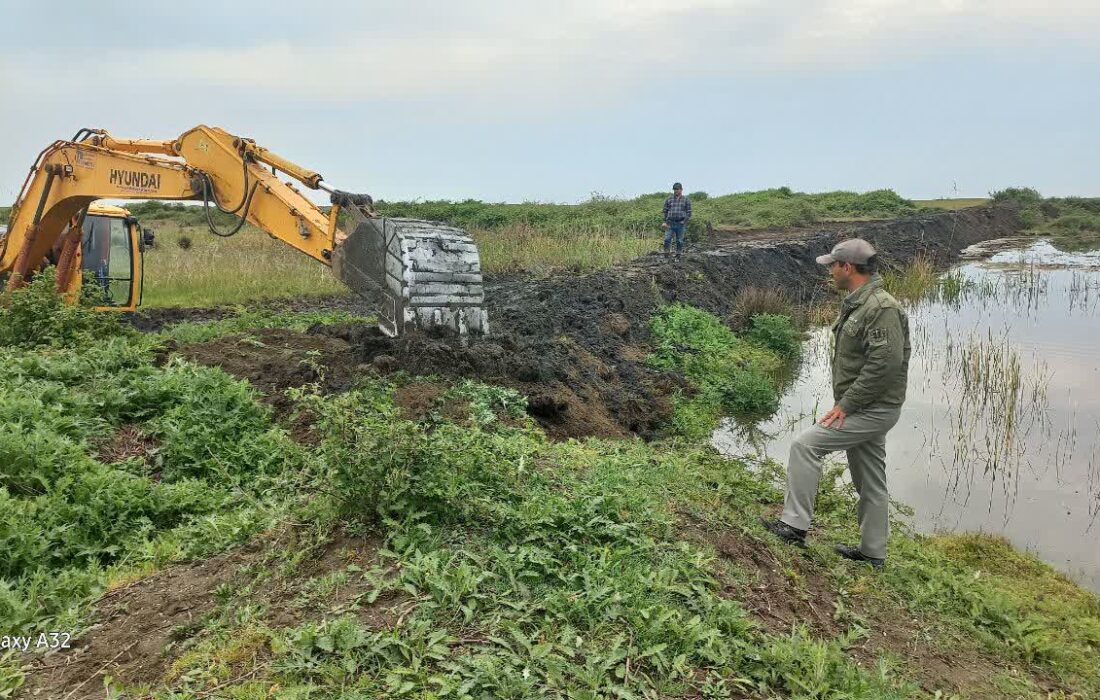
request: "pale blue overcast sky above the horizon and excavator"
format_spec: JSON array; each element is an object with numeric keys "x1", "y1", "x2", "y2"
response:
[{"x1": 0, "y1": 0, "x2": 1100, "y2": 205}]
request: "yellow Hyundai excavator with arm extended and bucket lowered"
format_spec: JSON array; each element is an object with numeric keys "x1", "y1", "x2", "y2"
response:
[{"x1": 0, "y1": 125, "x2": 488, "y2": 336}]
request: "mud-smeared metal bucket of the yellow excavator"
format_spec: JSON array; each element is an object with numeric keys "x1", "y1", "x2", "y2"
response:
[{"x1": 332, "y1": 206, "x2": 488, "y2": 336}]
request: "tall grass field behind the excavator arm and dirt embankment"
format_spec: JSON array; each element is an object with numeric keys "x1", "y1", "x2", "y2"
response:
[{"x1": 111, "y1": 188, "x2": 921, "y2": 306}]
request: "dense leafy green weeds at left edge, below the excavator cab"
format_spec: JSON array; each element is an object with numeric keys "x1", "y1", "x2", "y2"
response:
[{"x1": 0, "y1": 305, "x2": 308, "y2": 630}]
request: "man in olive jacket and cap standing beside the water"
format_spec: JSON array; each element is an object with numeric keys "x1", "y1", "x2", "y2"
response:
[{"x1": 765, "y1": 239, "x2": 910, "y2": 568}]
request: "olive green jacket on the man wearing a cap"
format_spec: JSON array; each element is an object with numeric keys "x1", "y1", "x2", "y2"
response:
[{"x1": 833, "y1": 275, "x2": 910, "y2": 414}]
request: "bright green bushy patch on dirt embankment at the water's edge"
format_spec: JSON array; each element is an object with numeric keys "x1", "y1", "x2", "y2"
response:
[{"x1": 649, "y1": 304, "x2": 801, "y2": 439}]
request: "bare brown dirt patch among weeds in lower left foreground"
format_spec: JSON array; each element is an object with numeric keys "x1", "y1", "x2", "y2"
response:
[{"x1": 21, "y1": 531, "x2": 391, "y2": 700}]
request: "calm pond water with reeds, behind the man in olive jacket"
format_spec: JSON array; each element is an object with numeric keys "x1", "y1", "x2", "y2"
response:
[{"x1": 714, "y1": 241, "x2": 1100, "y2": 592}]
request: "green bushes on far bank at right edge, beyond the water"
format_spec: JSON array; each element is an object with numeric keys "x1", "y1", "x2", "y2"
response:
[{"x1": 992, "y1": 187, "x2": 1100, "y2": 251}]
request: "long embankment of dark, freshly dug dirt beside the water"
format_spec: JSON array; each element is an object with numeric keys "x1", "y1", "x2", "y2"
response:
[{"x1": 171, "y1": 208, "x2": 1021, "y2": 437}]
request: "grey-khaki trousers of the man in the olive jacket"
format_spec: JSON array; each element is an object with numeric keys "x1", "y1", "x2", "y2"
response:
[{"x1": 781, "y1": 406, "x2": 901, "y2": 558}]
